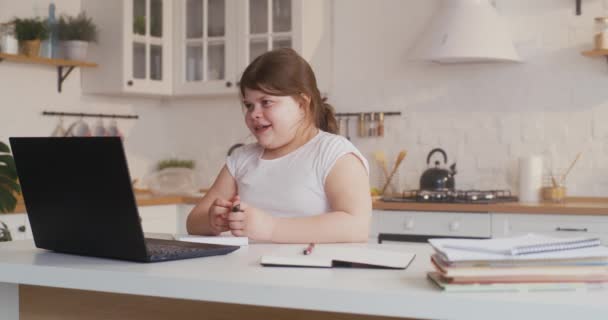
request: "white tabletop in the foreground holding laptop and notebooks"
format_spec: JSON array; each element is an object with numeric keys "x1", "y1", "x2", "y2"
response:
[{"x1": 0, "y1": 240, "x2": 608, "y2": 319}]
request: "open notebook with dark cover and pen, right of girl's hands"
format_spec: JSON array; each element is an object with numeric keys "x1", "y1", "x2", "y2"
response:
[{"x1": 260, "y1": 245, "x2": 415, "y2": 269}]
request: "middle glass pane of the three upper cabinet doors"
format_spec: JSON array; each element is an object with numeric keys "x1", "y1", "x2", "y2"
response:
[{"x1": 182, "y1": 0, "x2": 228, "y2": 82}]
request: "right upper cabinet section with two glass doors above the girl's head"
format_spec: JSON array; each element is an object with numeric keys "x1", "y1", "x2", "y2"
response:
[{"x1": 174, "y1": 0, "x2": 331, "y2": 95}]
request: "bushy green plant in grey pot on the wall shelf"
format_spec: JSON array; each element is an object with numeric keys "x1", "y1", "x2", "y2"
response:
[{"x1": 57, "y1": 12, "x2": 97, "y2": 60}]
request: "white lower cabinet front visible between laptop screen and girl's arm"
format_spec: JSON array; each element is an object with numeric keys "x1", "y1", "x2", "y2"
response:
[{"x1": 138, "y1": 204, "x2": 179, "y2": 234}]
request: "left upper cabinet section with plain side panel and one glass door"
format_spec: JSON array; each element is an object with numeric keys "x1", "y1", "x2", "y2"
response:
[{"x1": 81, "y1": 0, "x2": 173, "y2": 95}]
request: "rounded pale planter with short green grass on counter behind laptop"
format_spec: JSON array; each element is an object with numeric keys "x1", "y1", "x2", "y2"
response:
[{"x1": 146, "y1": 158, "x2": 198, "y2": 196}]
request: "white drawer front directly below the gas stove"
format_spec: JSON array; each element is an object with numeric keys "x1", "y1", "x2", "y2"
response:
[{"x1": 372, "y1": 211, "x2": 491, "y2": 237}]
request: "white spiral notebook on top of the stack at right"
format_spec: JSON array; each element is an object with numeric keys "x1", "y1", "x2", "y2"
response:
[{"x1": 429, "y1": 234, "x2": 601, "y2": 260}]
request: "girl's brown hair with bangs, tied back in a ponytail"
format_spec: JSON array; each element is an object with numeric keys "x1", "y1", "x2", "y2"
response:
[{"x1": 239, "y1": 48, "x2": 338, "y2": 133}]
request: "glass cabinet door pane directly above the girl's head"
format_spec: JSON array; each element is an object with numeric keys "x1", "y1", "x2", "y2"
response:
[{"x1": 245, "y1": 0, "x2": 293, "y2": 62}]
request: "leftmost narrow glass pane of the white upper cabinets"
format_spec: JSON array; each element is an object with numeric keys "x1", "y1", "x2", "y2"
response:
[{"x1": 129, "y1": 0, "x2": 168, "y2": 85}]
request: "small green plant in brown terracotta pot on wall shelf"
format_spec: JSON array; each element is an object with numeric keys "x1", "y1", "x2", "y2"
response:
[{"x1": 13, "y1": 18, "x2": 49, "y2": 57}]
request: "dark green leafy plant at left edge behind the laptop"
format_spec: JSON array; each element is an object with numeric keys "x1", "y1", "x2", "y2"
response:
[{"x1": 0, "y1": 142, "x2": 21, "y2": 212}]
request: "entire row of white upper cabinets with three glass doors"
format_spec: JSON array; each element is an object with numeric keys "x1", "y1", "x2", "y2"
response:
[{"x1": 82, "y1": 0, "x2": 332, "y2": 96}]
